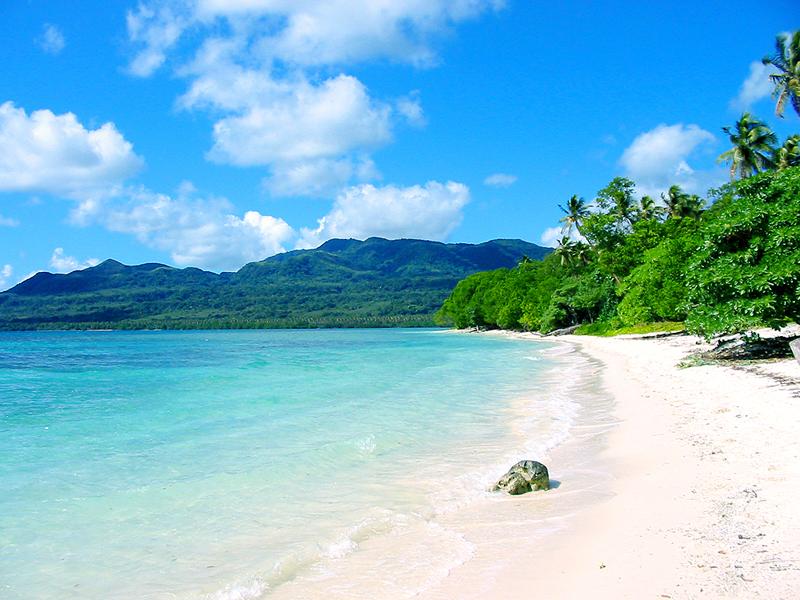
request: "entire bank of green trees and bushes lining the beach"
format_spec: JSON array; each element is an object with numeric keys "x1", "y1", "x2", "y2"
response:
[{"x1": 439, "y1": 167, "x2": 800, "y2": 336}]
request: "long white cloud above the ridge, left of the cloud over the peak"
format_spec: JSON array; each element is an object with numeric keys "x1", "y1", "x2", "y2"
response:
[{"x1": 73, "y1": 186, "x2": 295, "y2": 270}]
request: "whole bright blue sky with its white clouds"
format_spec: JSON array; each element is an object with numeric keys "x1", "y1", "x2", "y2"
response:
[{"x1": 0, "y1": 0, "x2": 800, "y2": 289}]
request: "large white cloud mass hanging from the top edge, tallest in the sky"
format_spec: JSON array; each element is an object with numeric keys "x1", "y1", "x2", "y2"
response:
[{"x1": 128, "y1": 0, "x2": 502, "y2": 196}]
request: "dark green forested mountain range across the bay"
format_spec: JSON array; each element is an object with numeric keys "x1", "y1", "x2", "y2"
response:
[{"x1": 0, "y1": 238, "x2": 550, "y2": 329}]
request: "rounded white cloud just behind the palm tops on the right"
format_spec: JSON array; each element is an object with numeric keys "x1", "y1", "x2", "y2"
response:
[{"x1": 620, "y1": 123, "x2": 725, "y2": 197}]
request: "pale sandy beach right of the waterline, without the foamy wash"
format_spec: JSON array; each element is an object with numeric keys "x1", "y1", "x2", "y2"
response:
[{"x1": 418, "y1": 336, "x2": 800, "y2": 600}]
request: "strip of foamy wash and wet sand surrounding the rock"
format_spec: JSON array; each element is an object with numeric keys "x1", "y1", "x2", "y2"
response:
[{"x1": 264, "y1": 331, "x2": 615, "y2": 600}]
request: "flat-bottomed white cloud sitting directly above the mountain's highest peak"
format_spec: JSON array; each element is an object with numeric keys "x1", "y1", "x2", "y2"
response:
[{"x1": 297, "y1": 181, "x2": 469, "y2": 248}]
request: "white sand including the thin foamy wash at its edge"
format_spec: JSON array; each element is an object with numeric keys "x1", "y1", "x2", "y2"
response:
[{"x1": 269, "y1": 333, "x2": 800, "y2": 600}]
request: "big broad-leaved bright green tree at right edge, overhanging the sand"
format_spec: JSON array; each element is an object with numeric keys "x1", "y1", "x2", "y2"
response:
[{"x1": 686, "y1": 167, "x2": 800, "y2": 337}]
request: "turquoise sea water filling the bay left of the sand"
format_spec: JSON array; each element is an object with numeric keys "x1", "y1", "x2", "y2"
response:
[{"x1": 0, "y1": 330, "x2": 569, "y2": 599}]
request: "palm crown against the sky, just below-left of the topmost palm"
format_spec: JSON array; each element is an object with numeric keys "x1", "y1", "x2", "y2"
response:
[{"x1": 717, "y1": 113, "x2": 778, "y2": 179}]
